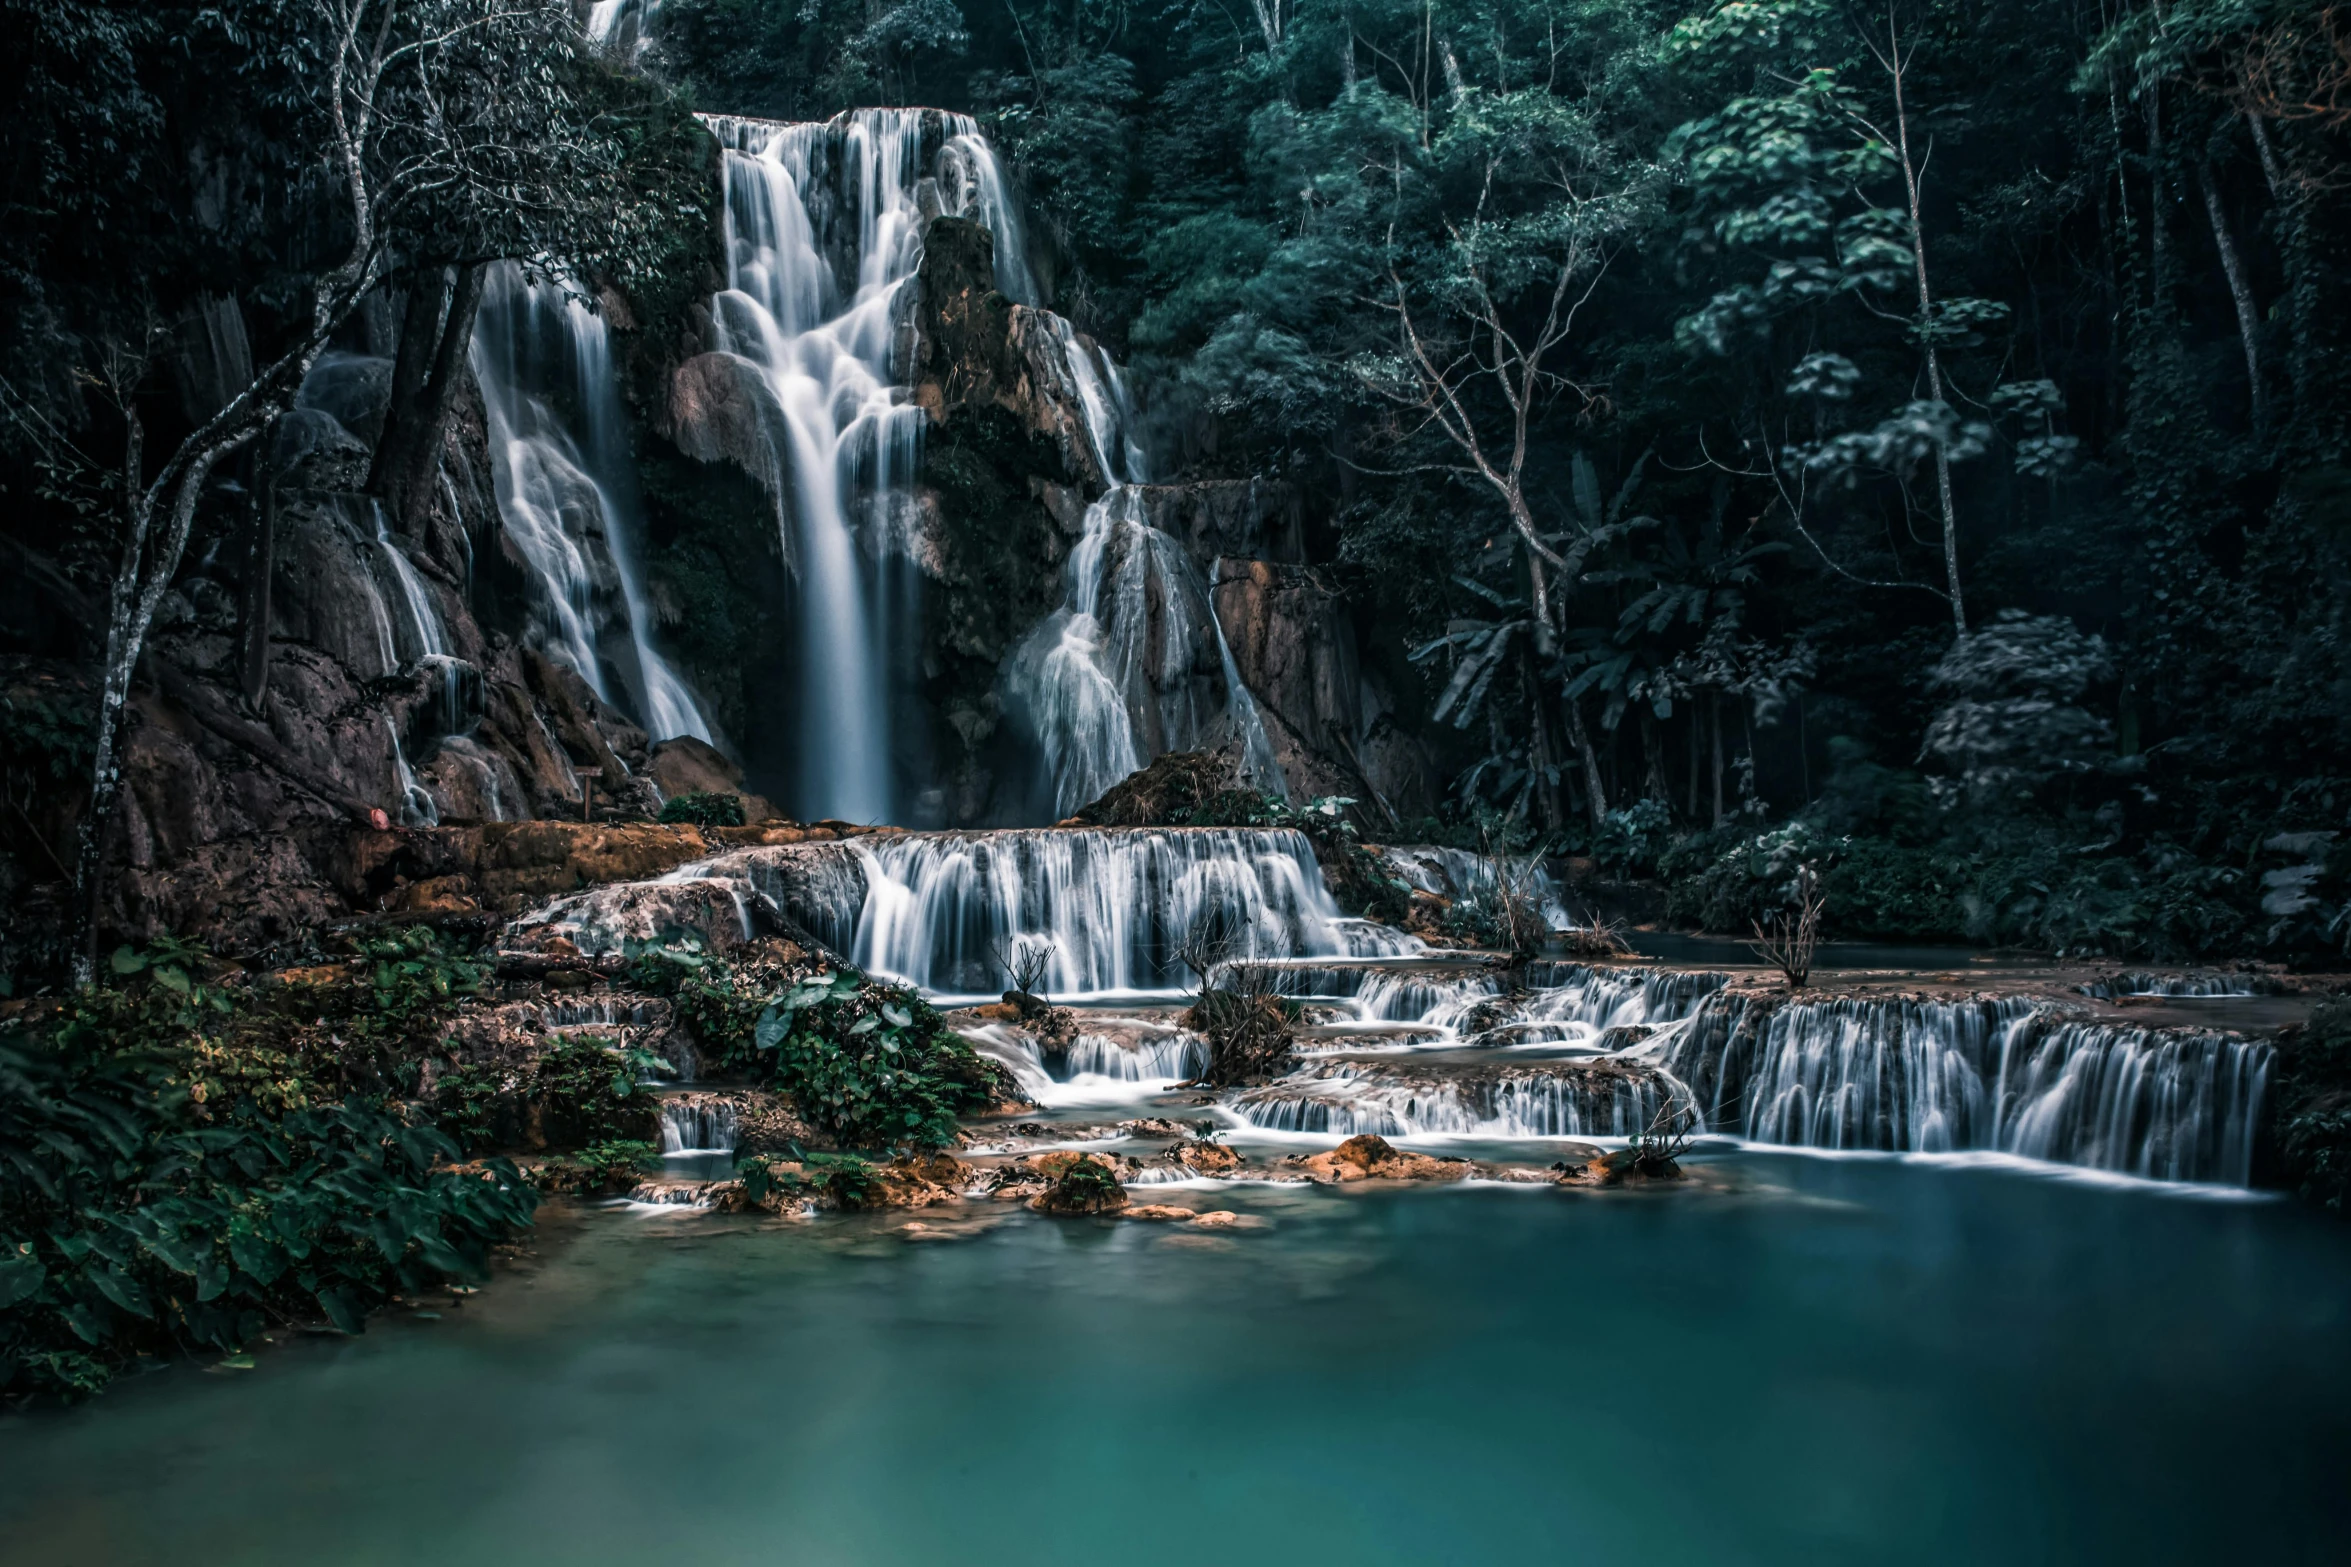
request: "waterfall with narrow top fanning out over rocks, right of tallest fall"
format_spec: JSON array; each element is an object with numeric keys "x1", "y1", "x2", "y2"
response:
[{"x1": 1004, "y1": 317, "x2": 1286, "y2": 818}]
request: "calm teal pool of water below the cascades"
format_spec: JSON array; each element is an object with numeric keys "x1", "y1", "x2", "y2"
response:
[{"x1": 0, "y1": 1151, "x2": 2351, "y2": 1567}]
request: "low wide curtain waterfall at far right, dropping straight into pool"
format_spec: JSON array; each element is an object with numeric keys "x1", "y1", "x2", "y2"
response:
[{"x1": 1662, "y1": 996, "x2": 2273, "y2": 1186}]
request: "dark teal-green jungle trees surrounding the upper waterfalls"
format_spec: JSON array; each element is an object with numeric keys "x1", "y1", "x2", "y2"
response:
[{"x1": 0, "y1": 0, "x2": 2351, "y2": 956}]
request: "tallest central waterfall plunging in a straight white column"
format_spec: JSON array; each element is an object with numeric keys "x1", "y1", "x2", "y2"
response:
[{"x1": 705, "y1": 108, "x2": 1030, "y2": 822}]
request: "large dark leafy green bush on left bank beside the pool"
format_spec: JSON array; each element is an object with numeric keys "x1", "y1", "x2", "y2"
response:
[{"x1": 0, "y1": 972, "x2": 536, "y2": 1398}]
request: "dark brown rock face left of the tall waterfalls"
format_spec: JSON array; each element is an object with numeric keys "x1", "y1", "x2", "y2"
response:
[{"x1": 0, "y1": 338, "x2": 714, "y2": 970}]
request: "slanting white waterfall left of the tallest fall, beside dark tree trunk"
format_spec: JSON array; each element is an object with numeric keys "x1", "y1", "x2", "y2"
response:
[{"x1": 473, "y1": 263, "x2": 712, "y2": 740}]
